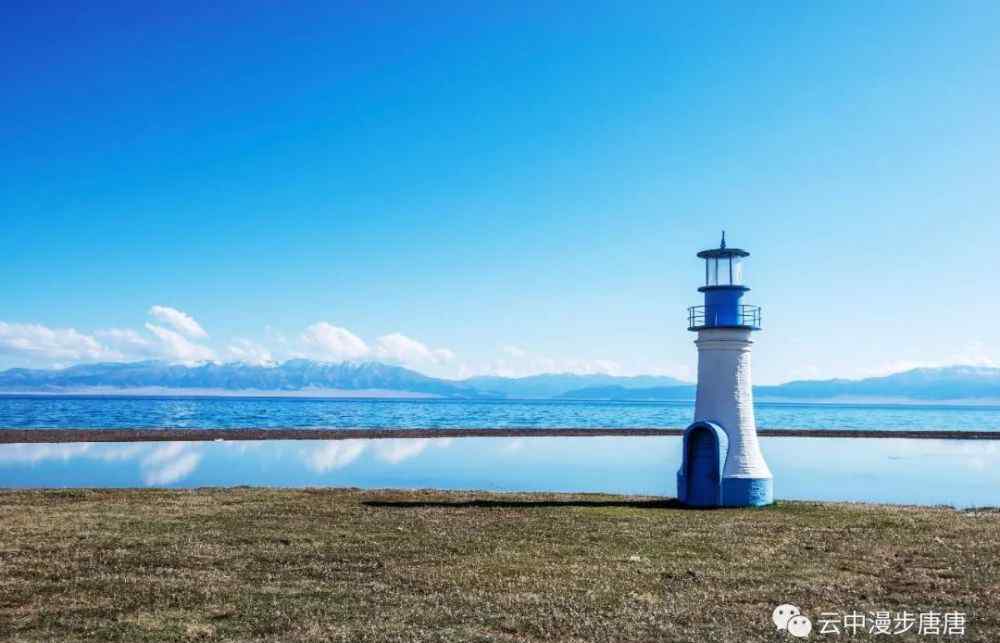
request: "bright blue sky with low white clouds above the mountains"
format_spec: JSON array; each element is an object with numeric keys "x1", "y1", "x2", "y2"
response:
[{"x1": 0, "y1": 2, "x2": 1000, "y2": 382}]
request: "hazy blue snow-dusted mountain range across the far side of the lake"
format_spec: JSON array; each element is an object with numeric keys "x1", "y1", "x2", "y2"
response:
[{"x1": 0, "y1": 359, "x2": 1000, "y2": 401}]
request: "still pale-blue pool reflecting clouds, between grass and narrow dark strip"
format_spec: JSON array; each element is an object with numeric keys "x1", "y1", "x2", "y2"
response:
[{"x1": 0, "y1": 437, "x2": 1000, "y2": 507}]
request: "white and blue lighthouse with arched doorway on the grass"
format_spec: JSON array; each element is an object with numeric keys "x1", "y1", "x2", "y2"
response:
[{"x1": 677, "y1": 232, "x2": 774, "y2": 507}]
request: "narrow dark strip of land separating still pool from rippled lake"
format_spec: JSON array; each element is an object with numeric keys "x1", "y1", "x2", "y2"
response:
[{"x1": 0, "y1": 427, "x2": 1000, "y2": 444}]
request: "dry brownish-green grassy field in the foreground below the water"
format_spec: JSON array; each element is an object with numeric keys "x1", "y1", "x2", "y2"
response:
[{"x1": 0, "y1": 488, "x2": 1000, "y2": 642}]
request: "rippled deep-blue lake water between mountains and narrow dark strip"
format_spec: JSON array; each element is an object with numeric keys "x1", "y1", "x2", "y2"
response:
[{"x1": 0, "y1": 397, "x2": 1000, "y2": 431}]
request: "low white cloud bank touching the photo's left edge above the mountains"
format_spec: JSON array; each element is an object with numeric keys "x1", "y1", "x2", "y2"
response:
[{"x1": 0, "y1": 321, "x2": 123, "y2": 362}]
